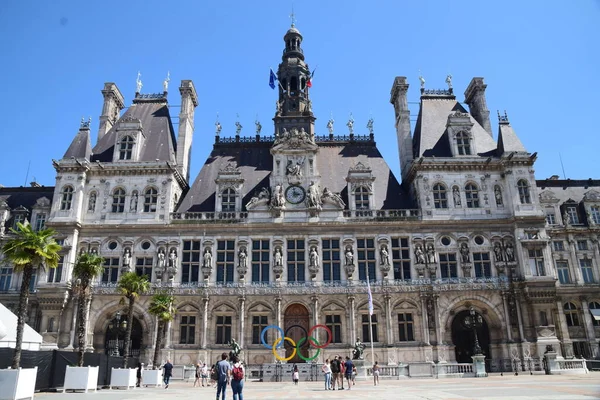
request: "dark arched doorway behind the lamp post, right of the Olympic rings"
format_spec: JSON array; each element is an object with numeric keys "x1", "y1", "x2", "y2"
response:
[{"x1": 452, "y1": 310, "x2": 490, "y2": 364}]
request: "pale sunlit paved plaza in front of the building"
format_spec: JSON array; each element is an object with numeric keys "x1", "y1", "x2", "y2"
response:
[{"x1": 35, "y1": 373, "x2": 600, "y2": 400}]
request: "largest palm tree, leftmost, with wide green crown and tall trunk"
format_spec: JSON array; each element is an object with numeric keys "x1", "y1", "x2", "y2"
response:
[{"x1": 2, "y1": 222, "x2": 61, "y2": 369}]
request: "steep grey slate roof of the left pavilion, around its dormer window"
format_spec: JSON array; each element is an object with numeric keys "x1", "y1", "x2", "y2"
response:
[{"x1": 92, "y1": 97, "x2": 177, "y2": 162}]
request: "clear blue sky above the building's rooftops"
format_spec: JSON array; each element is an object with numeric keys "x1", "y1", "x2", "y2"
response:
[{"x1": 0, "y1": 0, "x2": 600, "y2": 186}]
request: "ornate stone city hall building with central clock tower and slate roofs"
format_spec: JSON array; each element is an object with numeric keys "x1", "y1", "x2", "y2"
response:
[{"x1": 0, "y1": 26, "x2": 600, "y2": 370}]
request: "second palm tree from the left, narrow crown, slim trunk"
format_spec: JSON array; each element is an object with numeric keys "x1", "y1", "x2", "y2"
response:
[{"x1": 73, "y1": 253, "x2": 104, "y2": 367}]
